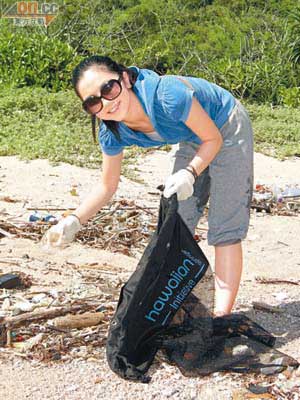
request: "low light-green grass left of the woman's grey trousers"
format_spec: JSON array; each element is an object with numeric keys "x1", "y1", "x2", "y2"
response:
[{"x1": 0, "y1": 88, "x2": 152, "y2": 177}]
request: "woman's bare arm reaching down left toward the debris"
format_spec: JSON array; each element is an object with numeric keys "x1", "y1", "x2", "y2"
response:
[{"x1": 73, "y1": 152, "x2": 123, "y2": 224}]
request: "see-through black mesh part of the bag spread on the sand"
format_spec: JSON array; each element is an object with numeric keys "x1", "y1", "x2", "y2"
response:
[{"x1": 156, "y1": 294, "x2": 299, "y2": 377}]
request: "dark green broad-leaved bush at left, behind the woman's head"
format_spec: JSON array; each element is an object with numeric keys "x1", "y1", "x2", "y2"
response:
[{"x1": 0, "y1": 27, "x2": 78, "y2": 91}]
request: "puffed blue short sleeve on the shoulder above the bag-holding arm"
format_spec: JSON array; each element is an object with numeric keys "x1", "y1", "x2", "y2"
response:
[{"x1": 157, "y1": 75, "x2": 194, "y2": 122}]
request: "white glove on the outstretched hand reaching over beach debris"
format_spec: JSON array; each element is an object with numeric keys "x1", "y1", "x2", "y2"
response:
[{"x1": 43, "y1": 215, "x2": 81, "y2": 247}]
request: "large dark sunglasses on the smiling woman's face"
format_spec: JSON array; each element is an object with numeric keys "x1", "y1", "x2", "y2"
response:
[{"x1": 82, "y1": 77, "x2": 122, "y2": 115}]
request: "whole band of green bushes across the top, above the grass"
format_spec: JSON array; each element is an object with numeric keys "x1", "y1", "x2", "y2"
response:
[{"x1": 0, "y1": 0, "x2": 300, "y2": 105}]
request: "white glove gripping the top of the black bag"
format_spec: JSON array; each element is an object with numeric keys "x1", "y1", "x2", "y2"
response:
[{"x1": 164, "y1": 169, "x2": 195, "y2": 201}]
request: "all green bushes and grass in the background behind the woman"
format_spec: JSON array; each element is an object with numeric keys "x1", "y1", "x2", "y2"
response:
[{"x1": 0, "y1": 0, "x2": 300, "y2": 166}]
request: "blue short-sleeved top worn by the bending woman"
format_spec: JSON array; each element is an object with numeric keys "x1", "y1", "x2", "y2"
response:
[{"x1": 99, "y1": 67, "x2": 235, "y2": 155}]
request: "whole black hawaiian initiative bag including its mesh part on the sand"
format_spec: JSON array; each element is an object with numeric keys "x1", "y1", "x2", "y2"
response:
[{"x1": 106, "y1": 196, "x2": 298, "y2": 382}]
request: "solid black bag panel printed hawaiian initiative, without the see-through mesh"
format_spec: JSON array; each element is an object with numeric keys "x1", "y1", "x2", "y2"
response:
[{"x1": 106, "y1": 195, "x2": 212, "y2": 381}]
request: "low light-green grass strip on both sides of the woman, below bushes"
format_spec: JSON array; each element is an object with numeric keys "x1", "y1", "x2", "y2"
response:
[{"x1": 0, "y1": 88, "x2": 300, "y2": 176}]
